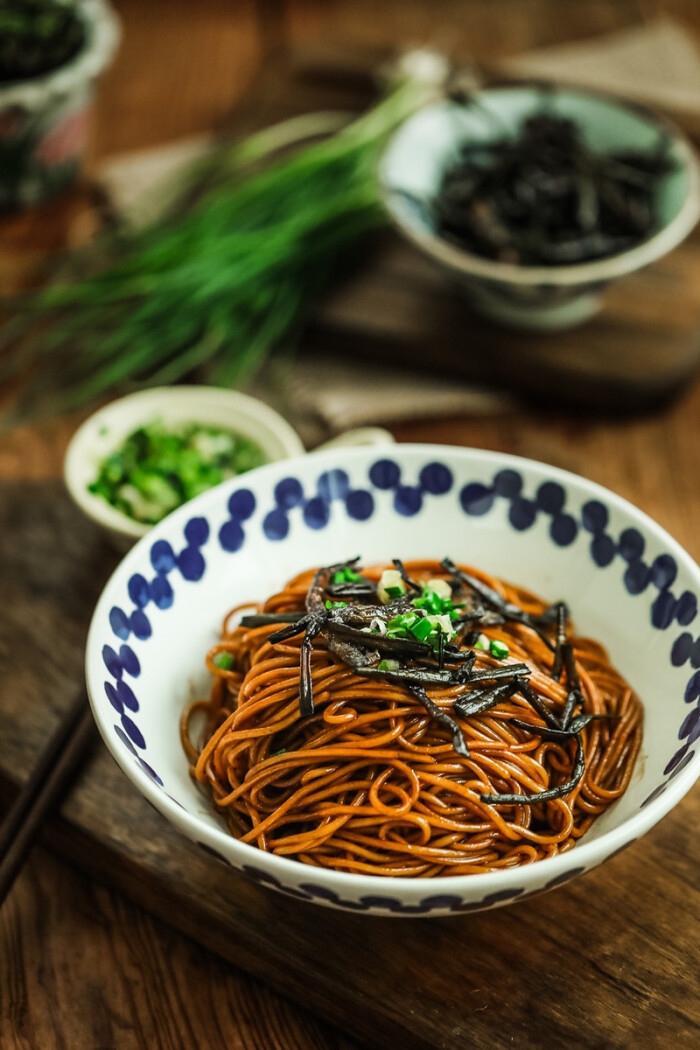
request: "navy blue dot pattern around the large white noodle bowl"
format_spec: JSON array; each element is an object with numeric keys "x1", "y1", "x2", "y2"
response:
[{"x1": 102, "y1": 457, "x2": 700, "y2": 915}]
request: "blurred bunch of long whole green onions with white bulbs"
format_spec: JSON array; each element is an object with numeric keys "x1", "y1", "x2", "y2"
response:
[{"x1": 0, "y1": 53, "x2": 445, "y2": 422}]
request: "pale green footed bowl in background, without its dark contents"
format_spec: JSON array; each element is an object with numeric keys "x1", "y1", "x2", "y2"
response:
[{"x1": 380, "y1": 84, "x2": 700, "y2": 329}]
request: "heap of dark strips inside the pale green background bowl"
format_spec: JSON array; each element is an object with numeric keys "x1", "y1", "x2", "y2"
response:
[{"x1": 432, "y1": 108, "x2": 675, "y2": 266}]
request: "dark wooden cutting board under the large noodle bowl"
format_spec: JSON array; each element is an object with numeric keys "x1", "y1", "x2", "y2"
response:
[{"x1": 0, "y1": 482, "x2": 700, "y2": 1050}]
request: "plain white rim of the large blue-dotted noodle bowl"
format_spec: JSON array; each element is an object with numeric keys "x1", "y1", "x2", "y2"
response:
[{"x1": 85, "y1": 443, "x2": 700, "y2": 901}]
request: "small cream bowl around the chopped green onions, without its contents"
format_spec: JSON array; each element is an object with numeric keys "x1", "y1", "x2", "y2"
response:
[{"x1": 63, "y1": 386, "x2": 304, "y2": 551}]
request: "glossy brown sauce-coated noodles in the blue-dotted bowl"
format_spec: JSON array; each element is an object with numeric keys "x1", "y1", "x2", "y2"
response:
[{"x1": 182, "y1": 561, "x2": 642, "y2": 878}]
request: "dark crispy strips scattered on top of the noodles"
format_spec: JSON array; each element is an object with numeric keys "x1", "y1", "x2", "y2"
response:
[{"x1": 257, "y1": 558, "x2": 575, "y2": 781}]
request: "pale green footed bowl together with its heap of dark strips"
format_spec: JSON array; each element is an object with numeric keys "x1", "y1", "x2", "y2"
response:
[{"x1": 380, "y1": 84, "x2": 700, "y2": 330}]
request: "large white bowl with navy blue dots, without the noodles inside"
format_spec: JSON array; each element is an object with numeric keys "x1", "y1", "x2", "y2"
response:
[{"x1": 87, "y1": 445, "x2": 700, "y2": 916}]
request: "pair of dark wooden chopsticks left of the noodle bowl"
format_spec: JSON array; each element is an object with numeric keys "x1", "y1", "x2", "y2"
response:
[{"x1": 0, "y1": 690, "x2": 94, "y2": 905}]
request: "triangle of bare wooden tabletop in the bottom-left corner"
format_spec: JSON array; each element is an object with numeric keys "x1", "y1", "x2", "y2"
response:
[{"x1": 0, "y1": 849, "x2": 356, "y2": 1050}]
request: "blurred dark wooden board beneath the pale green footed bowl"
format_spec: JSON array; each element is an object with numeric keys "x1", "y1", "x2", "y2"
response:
[{"x1": 306, "y1": 233, "x2": 700, "y2": 415}]
